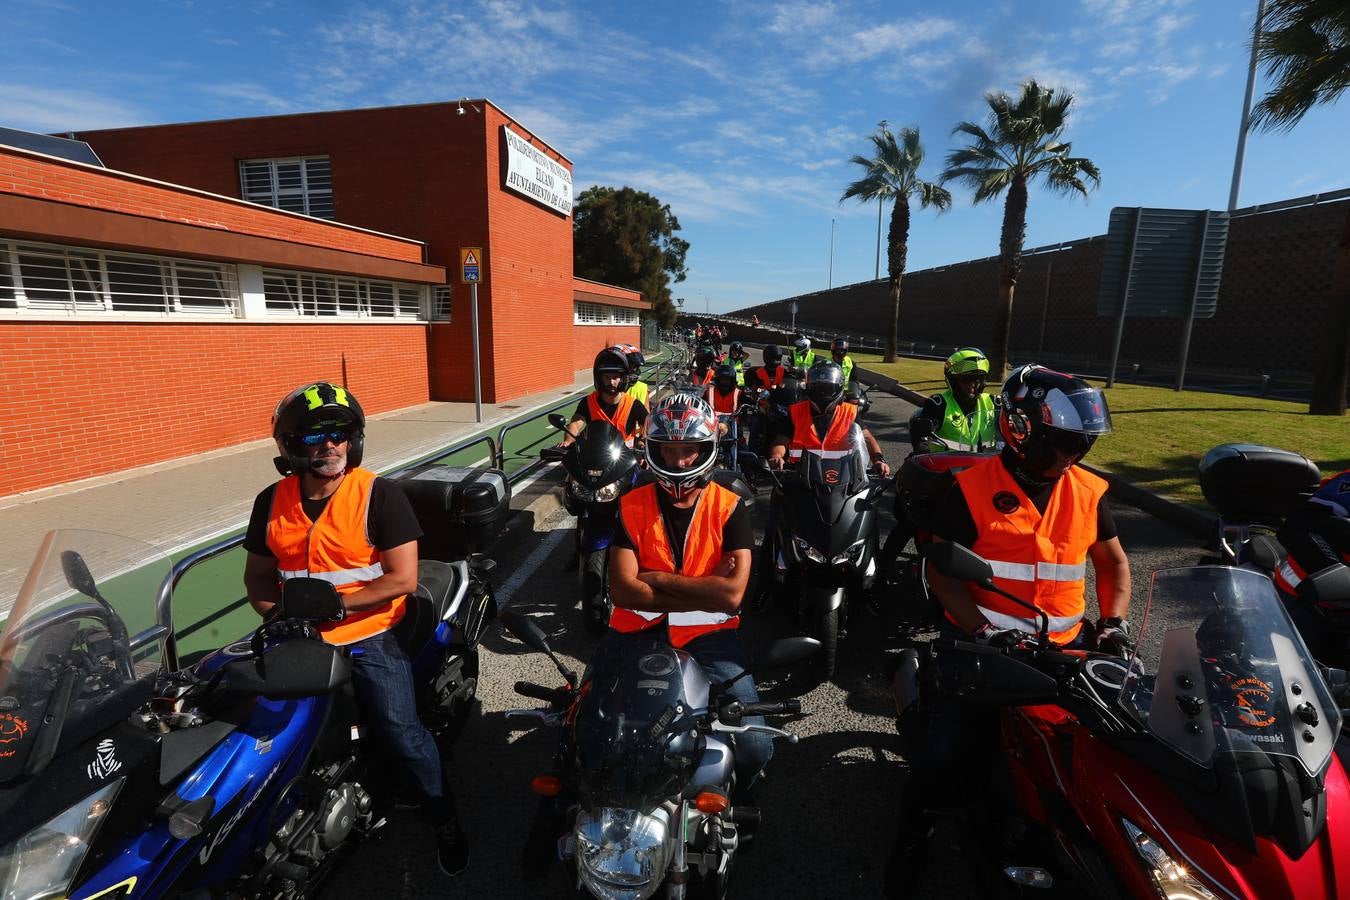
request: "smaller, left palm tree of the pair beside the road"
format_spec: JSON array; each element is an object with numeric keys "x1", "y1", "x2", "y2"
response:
[{"x1": 840, "y1": 121, "x2": 952, "y2": 363}]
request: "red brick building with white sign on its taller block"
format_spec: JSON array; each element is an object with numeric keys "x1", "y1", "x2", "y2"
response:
[{"x1": 0, "y1": 101, "x2": 647, "y2": 497}]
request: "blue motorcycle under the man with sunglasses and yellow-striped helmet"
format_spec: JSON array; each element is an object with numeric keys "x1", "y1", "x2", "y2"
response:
[{"x1": 0, "y1": 477, "x2": 495, "y2": 900}]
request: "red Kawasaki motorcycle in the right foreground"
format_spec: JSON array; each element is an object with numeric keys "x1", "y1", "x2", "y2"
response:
[{"x1": 896, "y1": 544, "x2": 1350, "y2": 900}]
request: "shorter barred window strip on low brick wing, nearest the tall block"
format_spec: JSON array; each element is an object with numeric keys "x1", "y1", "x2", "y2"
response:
[{"x1": 262, "y1": 269, "x2": 421, "y2": 318}]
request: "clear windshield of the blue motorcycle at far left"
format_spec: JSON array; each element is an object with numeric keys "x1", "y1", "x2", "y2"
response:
[{"x1": 0, "y1": 530, "x2": 171, "y2": 783}]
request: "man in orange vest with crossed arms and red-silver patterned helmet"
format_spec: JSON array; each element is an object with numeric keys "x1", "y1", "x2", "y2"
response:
[{"x1": 606, "y1": 394, "x2": 774, "y2": 803}]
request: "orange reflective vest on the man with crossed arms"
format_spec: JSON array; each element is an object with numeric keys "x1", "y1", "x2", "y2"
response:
[{"x1": 609, "y1": 482, "x2": 741, "y2": 646}]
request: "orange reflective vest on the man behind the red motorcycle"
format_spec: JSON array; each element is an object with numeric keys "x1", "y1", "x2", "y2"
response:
[{"x1": 948, "y1": 456, "x2": 1107, "y2": 644}]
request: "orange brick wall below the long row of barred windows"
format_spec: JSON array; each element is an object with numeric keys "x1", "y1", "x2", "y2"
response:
[{"x1": 0, "y1": 321, "x2": 428, "y2": 497}]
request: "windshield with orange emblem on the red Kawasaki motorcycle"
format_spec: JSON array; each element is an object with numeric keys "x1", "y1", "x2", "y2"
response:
[{"x1": 1121, "y1": 565, "x2": 1341, "y2": 777}]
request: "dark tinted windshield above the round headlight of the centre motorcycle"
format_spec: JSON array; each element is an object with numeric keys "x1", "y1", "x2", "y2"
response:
[{"x1": 572, "y1": 629, "x2": 697, "y2": 810}]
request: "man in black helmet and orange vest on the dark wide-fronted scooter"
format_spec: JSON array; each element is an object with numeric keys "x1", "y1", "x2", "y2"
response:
[{"x1": 768, "y1": 359, "x2": 891, "y2": 478}]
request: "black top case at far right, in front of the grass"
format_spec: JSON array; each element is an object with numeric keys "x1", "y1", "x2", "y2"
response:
[{"x1": 1200, "y1": 444, "x2": 1322, "y2": 525}]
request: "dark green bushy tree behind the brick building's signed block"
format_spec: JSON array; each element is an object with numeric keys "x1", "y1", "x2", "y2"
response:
[{"x1": 572, "y1": 185, "x2": 689, "y2": 328}]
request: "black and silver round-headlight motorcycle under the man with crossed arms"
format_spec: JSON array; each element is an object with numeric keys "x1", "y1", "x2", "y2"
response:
[{"x1": 498, "y1": 609, "x2": 819, "y2": 900}]
